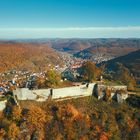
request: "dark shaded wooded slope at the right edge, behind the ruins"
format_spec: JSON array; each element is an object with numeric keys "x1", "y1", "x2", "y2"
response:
[{"x1": 105, "y1": 50, "x2": 140, "y2": 84}]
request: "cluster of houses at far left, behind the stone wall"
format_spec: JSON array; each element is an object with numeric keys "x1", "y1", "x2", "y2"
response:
[{"x1": 0, "y1": 70, "x2": 44, "y2": 94}]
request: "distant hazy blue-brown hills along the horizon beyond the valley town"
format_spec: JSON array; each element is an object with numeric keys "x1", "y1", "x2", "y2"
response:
[{"x1": 30, "y1": 38, "x2": 140, "y2": 58}]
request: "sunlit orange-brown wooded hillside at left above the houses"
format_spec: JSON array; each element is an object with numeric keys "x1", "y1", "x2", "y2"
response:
[{"x1": 0, "y1": 41, "x2": 62, "y2": 72}]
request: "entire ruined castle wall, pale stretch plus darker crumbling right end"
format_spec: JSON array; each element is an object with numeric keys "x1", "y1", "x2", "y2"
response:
[{"x1": 13, "y1": 83, "x2": 128, "y2": 102}]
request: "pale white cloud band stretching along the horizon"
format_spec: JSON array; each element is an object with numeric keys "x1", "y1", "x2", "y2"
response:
[{"x1": 0, "y1": 26, "x2": 140, "y2": 38}]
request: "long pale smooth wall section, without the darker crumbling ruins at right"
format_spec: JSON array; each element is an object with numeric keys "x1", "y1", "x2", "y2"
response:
[{"x1": 13, "y1": 83, "x2": 95, "y2": 101}]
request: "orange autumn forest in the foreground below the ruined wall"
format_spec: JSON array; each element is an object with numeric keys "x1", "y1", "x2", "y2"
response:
[{"x1": 0, "y1": 97, "x2": 140, "y2": 140}]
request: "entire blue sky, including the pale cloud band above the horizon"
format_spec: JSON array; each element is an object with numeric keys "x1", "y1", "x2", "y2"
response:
[{"x1": 0, "y1": 0, "x2": 140, "y2": 39}]
